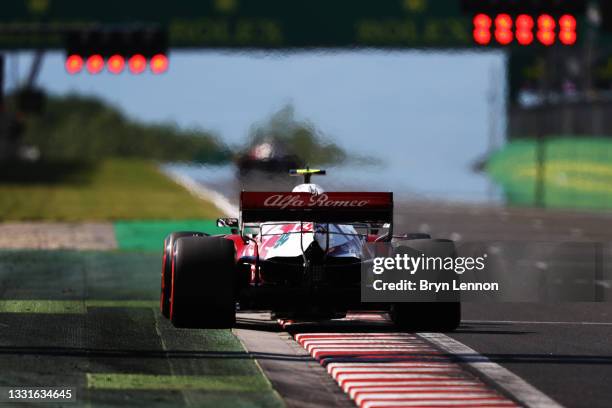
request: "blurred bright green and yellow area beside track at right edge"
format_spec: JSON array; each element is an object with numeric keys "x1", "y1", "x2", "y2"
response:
[{"x1": 487, "y1": 136, "x2": 612, "y2": 210}]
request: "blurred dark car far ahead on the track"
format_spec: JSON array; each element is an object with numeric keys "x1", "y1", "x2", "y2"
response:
[{"x1": 236, "y1": 138, "x2": 304, "y2": 177}]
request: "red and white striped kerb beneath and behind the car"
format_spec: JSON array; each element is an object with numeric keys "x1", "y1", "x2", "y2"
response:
[{"x1": 280, "y1": 312, "x2": 524, "y2": 408}]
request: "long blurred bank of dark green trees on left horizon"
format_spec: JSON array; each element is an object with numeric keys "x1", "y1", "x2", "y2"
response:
[{"x1": 17, "y1": 95, "x2": 231, "y2": 163}]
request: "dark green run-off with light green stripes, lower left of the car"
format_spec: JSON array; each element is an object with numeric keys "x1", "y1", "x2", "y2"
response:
[{"x1": 0, "y1": 250, "x2": 284, "y2": 408}]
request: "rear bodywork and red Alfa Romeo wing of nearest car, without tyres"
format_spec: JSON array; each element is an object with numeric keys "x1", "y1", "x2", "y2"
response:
[{"x1": 222, "y1": 192, "x2": 393, "y2": 312}]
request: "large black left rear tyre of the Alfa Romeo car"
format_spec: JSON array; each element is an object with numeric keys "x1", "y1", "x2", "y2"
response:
[{"x1": 170, "y1": 237, "x2": 236, "y2": 329}]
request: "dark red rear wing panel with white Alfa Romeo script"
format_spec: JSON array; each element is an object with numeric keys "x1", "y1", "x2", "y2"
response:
[{"x1": 240, "y1": 191, "x2": 393, "y2": 223}]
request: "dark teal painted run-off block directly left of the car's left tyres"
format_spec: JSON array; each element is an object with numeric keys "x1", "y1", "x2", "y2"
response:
[{"x1": 0, "y1": 249, "x2": 162, "y2": 300}]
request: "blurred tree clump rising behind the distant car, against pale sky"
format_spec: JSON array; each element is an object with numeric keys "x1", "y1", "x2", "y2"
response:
[{"x1": 248, "y1": 105, "x2": 347, "y2": 165}]
